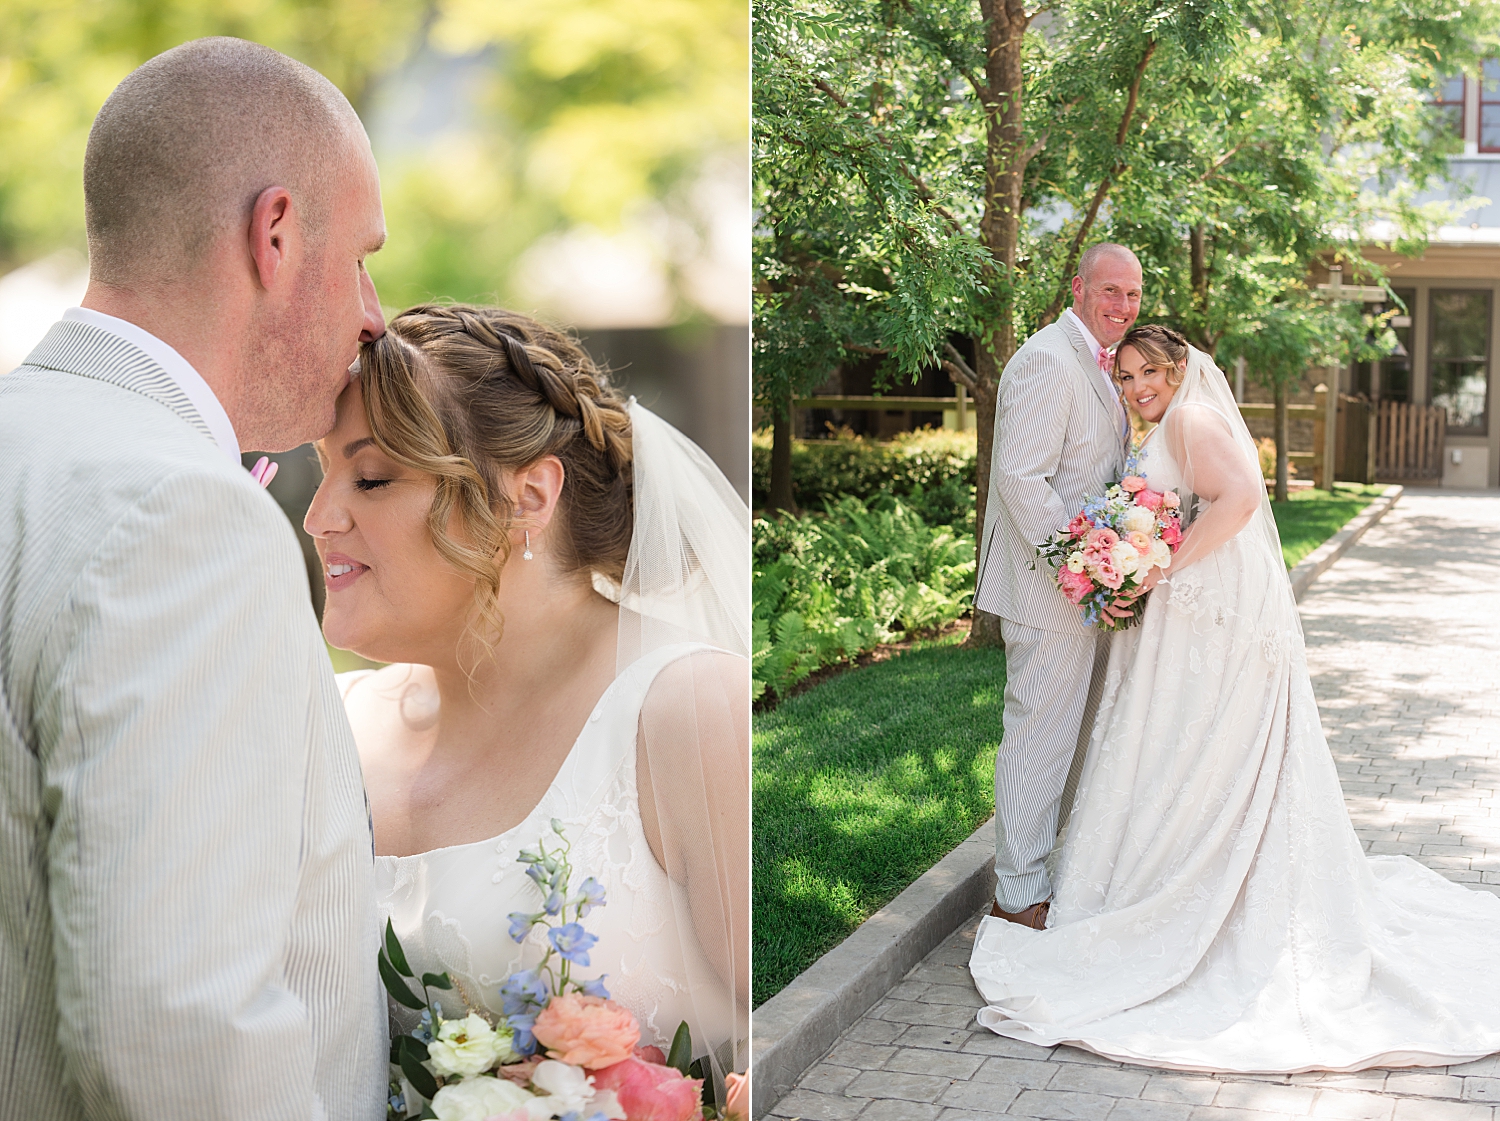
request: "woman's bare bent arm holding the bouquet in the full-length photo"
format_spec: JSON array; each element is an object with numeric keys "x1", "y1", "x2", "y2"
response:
[{"x1": 1163, "y1": 405, "x2": 1266, "y2": 579}]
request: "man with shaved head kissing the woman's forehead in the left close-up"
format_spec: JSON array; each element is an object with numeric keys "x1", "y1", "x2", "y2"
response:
[{"x1": 0, "y1": 39, "x2": 387, "y2": 1121}]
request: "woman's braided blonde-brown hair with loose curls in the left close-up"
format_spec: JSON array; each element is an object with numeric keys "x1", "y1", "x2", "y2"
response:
[{"x1": 360, "y1": 303, "x2": 635, "y2": 645}]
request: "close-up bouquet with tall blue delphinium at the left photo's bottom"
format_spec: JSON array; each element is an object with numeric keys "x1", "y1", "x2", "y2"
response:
[{"x1": 380, "y1": 819, "x2": 746, "y2": 1121}]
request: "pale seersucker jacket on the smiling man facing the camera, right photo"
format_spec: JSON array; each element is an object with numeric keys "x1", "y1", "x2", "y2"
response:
[{"x1": 974, "y1": 318, "x2": 1127, "y2": 635}]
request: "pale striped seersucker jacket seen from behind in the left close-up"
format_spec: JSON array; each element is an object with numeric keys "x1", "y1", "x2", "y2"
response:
[{"x1": 0, "y1": 321, "x2": 389, "y2": 1121}]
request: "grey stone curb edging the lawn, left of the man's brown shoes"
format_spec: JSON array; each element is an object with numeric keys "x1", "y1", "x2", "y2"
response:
[{"x1": 750, "y1": 818, "x2": 995, "y2": 1121}]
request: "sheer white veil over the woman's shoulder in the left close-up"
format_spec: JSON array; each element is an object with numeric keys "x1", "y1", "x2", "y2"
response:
[{"x1": 612, "y1": 398, "x2": 750, "y2": 1103}]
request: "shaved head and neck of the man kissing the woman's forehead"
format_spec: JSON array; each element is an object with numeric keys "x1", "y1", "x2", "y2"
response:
[{"x1": 84, "y1": 38, "x2": 386, "y2": 450}]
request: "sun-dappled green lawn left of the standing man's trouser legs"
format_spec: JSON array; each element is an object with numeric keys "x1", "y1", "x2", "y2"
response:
[{"x1": 752, "y1": 645, "x2": 1005, "y2": 1005}]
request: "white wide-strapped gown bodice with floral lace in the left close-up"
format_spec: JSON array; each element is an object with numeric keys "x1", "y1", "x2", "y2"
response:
[{"x1": 341, "y1": 642, "x2": 732, "y2": 1052}]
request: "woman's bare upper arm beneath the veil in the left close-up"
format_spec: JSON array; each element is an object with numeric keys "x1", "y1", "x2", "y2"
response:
[{"x1": 636, "y1": 651, "x2": 750, "y2": 1001}]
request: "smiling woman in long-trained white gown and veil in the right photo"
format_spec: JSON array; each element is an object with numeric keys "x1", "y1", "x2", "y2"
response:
[{"x1": 971, "y1": 327, "x2": 1500, "y2": 1073}]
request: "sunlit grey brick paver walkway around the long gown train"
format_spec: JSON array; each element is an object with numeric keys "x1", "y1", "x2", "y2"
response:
[{"x1": 771, "y1": 491, "x2": 1500, "y2": 1121}]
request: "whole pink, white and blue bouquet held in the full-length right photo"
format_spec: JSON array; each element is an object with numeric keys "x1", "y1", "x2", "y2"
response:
[{"x1": 1037, "y1": 456, "x2": 1182, "y2": 630}]
